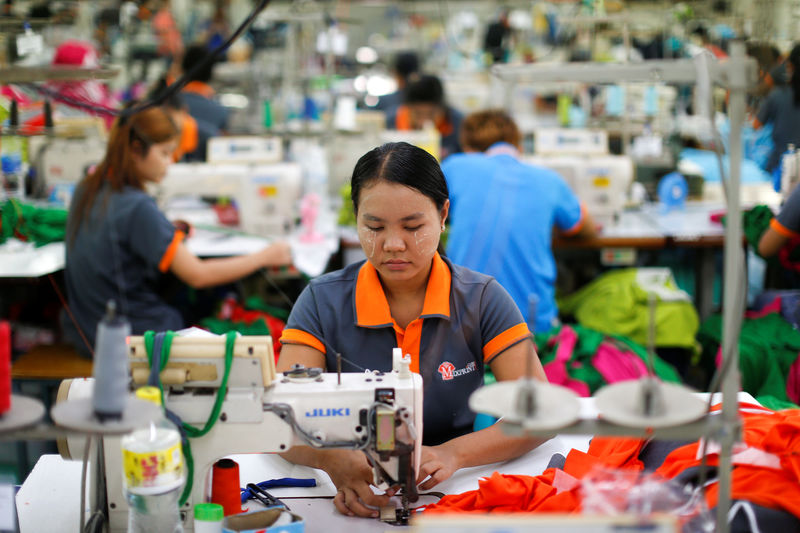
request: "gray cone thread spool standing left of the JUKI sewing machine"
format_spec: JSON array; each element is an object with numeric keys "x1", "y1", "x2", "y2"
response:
[{"x1": 92, "y1": 300, "x2": 131, "y2": 421}]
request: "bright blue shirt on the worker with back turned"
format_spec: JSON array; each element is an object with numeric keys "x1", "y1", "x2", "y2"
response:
[{"x1": 442, "y1": 145, "x2": 582, "y2": 331}]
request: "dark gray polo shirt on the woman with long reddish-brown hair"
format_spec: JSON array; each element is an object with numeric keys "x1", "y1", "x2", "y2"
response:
[{"x1": 62, "y1": 186, "x2": 183, "y2": 355}]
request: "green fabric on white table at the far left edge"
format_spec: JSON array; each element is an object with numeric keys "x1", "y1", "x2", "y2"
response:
[{"x1": 0, "y1": 200, "x2": 67, "y2": 246}]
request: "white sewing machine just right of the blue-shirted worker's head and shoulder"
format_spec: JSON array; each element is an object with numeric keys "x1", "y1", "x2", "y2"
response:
[{"x1": 523, "y1": 129, "x2": 634, "y2": 225}]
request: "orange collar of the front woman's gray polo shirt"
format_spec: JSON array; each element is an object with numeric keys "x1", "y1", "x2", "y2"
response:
[{"x1": 355, "y1": 252, "x2": 451, "y2": 328}]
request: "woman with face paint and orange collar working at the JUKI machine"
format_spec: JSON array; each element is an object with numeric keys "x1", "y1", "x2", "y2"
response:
[{"x1": 278, "y1": 143, "x2": 546, "y2": 517}]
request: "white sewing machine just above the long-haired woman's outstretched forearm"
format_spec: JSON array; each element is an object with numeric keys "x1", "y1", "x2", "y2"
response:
[{"x1": 152, "y1": 163, "x2": 303, "y2": 237}]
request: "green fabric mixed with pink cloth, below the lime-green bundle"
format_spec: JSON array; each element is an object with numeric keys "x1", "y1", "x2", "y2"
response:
[{"x1": 534, "y1": 324, "x2": 681, "y2": 393}]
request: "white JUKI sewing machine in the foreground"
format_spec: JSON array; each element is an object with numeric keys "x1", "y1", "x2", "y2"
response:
[{"x1": 62, "y1": 336, "x2": 422, "y2": 532}]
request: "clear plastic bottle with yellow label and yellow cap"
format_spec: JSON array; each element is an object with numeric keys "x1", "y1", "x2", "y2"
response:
[{"x1": 121, "y1": 387, "x2": 185, "y2": 533}]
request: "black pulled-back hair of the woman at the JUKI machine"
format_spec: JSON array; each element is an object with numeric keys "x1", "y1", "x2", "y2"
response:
[{"x1": 350, "y1": 142, "x2": 450, "y2": 213}]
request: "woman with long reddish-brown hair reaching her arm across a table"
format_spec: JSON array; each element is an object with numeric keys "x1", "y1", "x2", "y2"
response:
[{"x1": 62, "y1": 107, "x2": 291, "y2": 356}]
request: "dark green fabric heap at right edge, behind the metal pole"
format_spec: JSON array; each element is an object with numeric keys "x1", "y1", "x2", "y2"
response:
[{"x1": 697, "y1": 313, "x2": 800, "y2": 402}]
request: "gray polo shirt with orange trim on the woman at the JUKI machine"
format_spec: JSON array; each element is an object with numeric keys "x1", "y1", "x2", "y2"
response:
[{"x1": 281, "y1": 254, "x2": 531, "y2": 445}]
